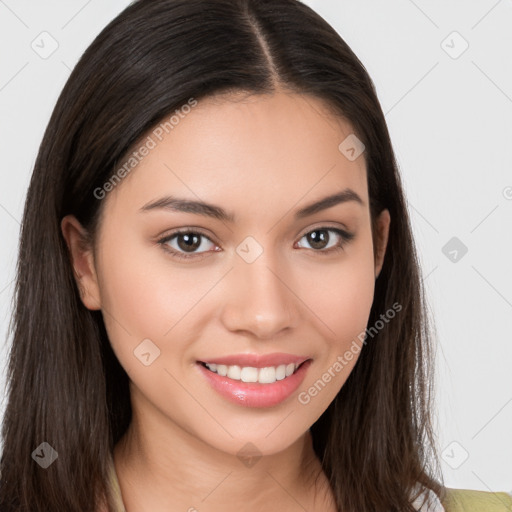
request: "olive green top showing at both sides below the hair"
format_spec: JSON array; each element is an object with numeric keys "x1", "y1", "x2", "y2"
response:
[{"x1": 105, "y1": 459, "x2": 512, "y2": 512}]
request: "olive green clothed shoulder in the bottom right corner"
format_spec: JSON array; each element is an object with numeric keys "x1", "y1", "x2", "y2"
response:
[{"x1": 442, "y1": 488, "x2": 512, "y2": 512}]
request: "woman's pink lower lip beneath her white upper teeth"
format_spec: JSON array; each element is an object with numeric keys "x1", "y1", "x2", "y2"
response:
[{"x1": 197, "y1": 359, "x2": 311, "y2": 407}]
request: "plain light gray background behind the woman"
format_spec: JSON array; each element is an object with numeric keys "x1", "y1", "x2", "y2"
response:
[{"x1": 0, "y1": 0, "x2": 512, "y2": 492}]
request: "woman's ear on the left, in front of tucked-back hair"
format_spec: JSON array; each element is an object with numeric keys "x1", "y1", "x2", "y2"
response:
[{"x1": 60, "y1": 215, "x2": 101, "y2": 310}]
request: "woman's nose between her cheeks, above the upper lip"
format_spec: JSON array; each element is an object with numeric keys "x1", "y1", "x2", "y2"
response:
[{"x1": 221, "y1": 252, "x2": 300, "y2": 339}]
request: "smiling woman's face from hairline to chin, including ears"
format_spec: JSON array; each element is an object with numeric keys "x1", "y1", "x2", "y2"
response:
[{"x1": 62, "y1": 92, "x2": 389, "y2": 454}]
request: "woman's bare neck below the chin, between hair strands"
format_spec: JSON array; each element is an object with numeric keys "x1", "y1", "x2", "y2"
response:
[{"x1": 114, "y1": 404, "x2": 335, "y2": 512}]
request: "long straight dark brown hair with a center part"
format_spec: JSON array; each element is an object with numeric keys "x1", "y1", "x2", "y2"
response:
[{"x1": 0, "y1": 0, "x2": 444, "y2": 512}]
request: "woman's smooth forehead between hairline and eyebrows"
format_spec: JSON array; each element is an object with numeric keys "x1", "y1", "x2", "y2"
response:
[{"x1": 108, "y1": 92, "x2": 368, "y2": 217}]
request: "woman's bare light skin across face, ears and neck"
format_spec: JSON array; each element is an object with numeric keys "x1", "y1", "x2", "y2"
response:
[{"x1": 61, "y1": 91, "x2": 390, "y2": 512}]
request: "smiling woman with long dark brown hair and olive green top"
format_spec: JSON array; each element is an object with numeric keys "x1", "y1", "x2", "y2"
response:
[{"x1": 0, "y1": 0, "x2": 512, "y2": 512}]
